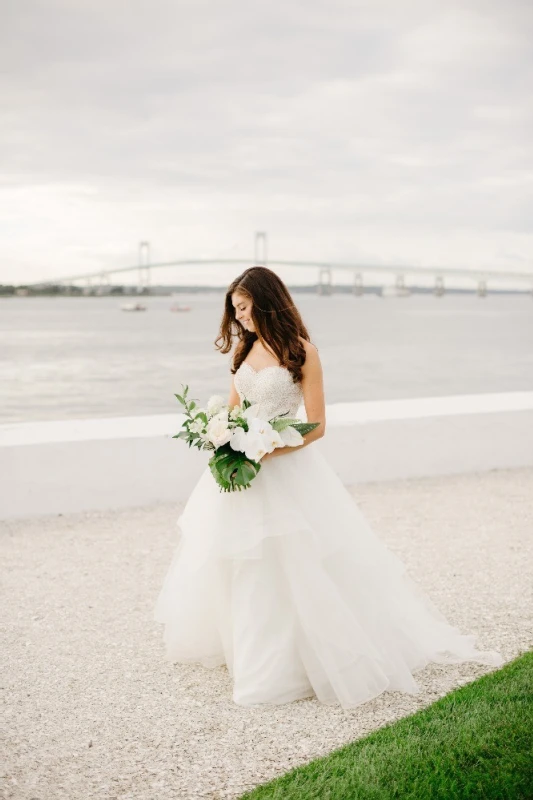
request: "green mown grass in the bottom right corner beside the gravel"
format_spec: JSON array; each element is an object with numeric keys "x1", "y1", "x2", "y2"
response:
[{"x1": 241, "y1": 652, "x2": 533, "y2": 800}]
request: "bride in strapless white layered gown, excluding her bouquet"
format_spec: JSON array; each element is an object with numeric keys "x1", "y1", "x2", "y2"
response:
[{"x1": 154, "y1": 267, "x2": 502, "y2": 708}]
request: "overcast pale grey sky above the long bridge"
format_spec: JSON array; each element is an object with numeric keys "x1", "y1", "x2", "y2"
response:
[{"x1": 0, "y1": 0, "x2": 533, "y2": 285}]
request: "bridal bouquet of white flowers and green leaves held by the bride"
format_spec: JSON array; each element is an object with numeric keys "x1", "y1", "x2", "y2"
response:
[{"x1": 172, "y1": 386, "x2": 320, "y2": 492}]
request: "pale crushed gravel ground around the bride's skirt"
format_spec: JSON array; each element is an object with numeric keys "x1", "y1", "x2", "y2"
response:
[{"x1": 1, "y1": 469, "x2": 533, "y2": 800}]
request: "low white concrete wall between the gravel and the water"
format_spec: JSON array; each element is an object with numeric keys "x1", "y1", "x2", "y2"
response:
[{"x1": 0, "y1": 392, "x2": 533, "y2": 519}]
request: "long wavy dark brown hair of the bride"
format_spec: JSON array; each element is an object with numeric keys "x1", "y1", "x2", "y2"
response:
[{"x1": 215, "y1": 267, "x2": 311, "y2": 382}]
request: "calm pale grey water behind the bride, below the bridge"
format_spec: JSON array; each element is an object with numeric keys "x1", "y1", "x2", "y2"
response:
[{"x1": 0, "y1": 293, "x2": 533, "y2": 423}]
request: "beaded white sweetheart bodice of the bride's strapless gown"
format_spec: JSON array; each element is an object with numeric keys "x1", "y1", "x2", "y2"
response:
[{"x1": 234, "y1": 361, "x2": 303, "y2": 419}]
